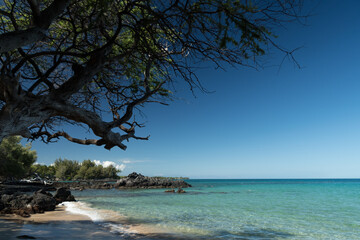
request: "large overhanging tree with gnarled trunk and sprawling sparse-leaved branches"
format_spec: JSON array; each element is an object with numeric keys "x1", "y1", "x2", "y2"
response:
[{"x1": 0, "y1": 0, "x2": 302, "y2": 149}]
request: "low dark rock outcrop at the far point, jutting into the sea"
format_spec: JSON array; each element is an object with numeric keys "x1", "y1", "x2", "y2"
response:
[{"x1": 114, "y1": 172, "x2": 191, "y2": 188}]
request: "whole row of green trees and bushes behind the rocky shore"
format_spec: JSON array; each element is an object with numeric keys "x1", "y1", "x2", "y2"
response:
[{"x1": 0, "y1": 137, "x2": 120, "y2": 180}]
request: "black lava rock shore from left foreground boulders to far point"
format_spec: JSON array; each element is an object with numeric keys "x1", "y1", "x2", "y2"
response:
[{"x1": 0, "y1": 172, "x2": 191, "y2": 217}]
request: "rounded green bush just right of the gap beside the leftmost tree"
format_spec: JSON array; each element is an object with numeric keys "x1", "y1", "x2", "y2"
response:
[{"x1": 54, "y1": 158, "x2": 80, "y2": 180}]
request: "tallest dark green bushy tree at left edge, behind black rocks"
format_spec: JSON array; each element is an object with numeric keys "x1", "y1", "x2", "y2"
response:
[{"x1": 0, "y1": 137, "x2": 37, "y2": 178}]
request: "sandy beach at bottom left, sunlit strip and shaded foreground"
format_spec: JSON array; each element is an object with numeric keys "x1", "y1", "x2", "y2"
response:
[{"x1": 0, "y1": 202, "x2": 181, "y2": 240}]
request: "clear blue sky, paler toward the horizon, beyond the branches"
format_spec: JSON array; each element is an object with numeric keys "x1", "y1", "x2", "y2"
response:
[{"x1": 26, "y1": 0, "x2": 360, "y2": 178}]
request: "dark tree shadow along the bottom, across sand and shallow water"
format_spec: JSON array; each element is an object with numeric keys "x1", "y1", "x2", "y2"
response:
[{"x1": 0, "y1": 219, "x2": 294, "y2": 240}]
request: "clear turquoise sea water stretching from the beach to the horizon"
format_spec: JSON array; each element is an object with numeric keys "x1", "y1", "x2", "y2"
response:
[{"x1": 75, "y1": 180, "x2": 360, "y2": 239}]
